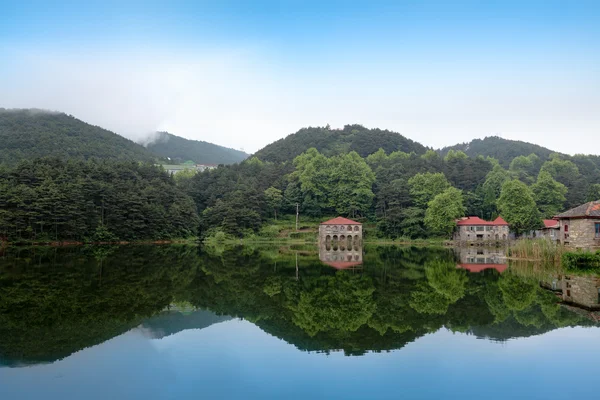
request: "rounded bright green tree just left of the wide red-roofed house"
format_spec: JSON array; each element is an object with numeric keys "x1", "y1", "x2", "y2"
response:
[{"x1": 425, "y1": 187, "x2": 465, "y2": 236}]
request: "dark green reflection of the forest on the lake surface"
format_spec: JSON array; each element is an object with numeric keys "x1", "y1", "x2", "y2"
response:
[{"x1": 0, "y1": 246, "x2": 593, "y2": 366}]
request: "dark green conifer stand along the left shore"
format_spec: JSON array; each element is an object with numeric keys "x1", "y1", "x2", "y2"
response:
[{"x1": 0, "y1": 159, "x2": 198, "y2": 242}]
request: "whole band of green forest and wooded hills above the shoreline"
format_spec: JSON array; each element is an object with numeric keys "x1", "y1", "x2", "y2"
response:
[{"x1": 0, "y1": 115, "x2": 600, "y2": 241}]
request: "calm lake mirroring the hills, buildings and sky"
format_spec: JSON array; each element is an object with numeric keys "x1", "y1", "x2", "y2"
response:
[{"x1": 0, "y1": 246, "x2": 600, "y2": 399}]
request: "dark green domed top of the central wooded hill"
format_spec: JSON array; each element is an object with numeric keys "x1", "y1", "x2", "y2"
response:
[{"x1": 255, "y1": 125, "x2": 427, "y2": 162}]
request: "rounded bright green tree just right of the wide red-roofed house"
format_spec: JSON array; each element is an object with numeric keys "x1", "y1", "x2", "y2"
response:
[{"x1": 498, "y1": 179, "x2": 542, "y2": 235}]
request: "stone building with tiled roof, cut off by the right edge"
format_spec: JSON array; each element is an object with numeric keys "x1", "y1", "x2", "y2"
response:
[{"x1": 554, "y1": 200, "x2": 600, "y2": 248}]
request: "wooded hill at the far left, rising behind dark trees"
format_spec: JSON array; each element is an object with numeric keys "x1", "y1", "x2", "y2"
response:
[{"x1": 0, "y1": 108, "x2": 156, "y2": 165}]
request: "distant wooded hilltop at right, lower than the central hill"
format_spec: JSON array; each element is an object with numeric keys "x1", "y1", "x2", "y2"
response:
[{"x1": 439, "y1": 136, "x2": 558, "y2": 168}]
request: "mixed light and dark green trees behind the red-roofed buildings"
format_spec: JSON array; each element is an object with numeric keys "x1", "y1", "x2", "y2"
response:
[{"x1": 185, "y1": 148, "x2": 600, "y2": 238}]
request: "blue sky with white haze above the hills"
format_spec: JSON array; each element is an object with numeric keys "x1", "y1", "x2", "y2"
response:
[{"x1": 0, "y1": 0, "x2": 600, "y2": 153}]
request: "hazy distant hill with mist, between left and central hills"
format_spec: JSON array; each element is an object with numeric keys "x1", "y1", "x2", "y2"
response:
[{"x1": 147, "y1": 132, "x2": 248, "y2": 164}]
